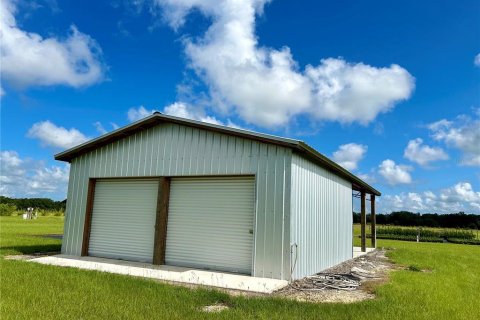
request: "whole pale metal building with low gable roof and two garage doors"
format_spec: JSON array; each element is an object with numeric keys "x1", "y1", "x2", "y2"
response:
[{"x1": 55, "y1": 113, "x2": 380, "y2": 280}]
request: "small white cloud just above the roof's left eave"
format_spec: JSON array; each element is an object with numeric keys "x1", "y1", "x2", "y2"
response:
[{"x1": 27, "y1": 120, "x2": 90, "y2": 149}]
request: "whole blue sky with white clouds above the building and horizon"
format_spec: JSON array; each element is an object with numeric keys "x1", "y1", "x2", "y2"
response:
[{"x1": 0, "y1": 0, "x2": 480, "y2": 213}]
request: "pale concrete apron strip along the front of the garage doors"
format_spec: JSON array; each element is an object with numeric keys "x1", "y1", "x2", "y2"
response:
[{"x1": 29, "y1": 254, "x2": 288, "y2": 293}]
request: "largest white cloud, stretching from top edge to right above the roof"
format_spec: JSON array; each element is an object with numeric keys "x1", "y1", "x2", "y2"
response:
[{"x1": 152, "y1": 0, "x2": 415, "y2": 128}]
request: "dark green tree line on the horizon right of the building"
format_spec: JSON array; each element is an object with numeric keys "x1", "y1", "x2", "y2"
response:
[{"x1": 353, "y1": 211, "x2": 480, "y2": 229}]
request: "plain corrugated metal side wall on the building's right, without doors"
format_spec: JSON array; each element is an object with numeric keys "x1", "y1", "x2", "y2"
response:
[{"x1": 290, "y1": 154, "x2": 353, "y2": 279}]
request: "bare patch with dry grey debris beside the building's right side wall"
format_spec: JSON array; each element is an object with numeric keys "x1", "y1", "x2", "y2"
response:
[{"x1": 276, "y1": 249, "x2": 393, "y2": 303}]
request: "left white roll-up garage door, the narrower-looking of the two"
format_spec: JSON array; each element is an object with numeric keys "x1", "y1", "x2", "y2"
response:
[{"x1": 88, "y1": 179, "x2": 158, "y2": 262}]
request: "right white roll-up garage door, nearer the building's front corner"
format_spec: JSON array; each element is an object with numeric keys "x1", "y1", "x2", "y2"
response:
[{"x1": 165, "y1": 177, "x2": 255, "y2": 274}]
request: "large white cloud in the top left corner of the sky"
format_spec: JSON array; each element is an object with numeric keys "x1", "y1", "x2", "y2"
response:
[{"x1": 0, "y1": 0, "x2": 105, "y2": 88}]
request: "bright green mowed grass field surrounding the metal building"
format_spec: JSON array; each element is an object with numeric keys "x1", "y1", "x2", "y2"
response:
[{"x1": 0, "y1": 217, "x2": 480, "y2": 320}]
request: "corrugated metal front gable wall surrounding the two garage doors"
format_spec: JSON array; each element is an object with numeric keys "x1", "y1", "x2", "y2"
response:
[{"x1": 62, "y1": 123, "x2": 292, "y2": 279}]
